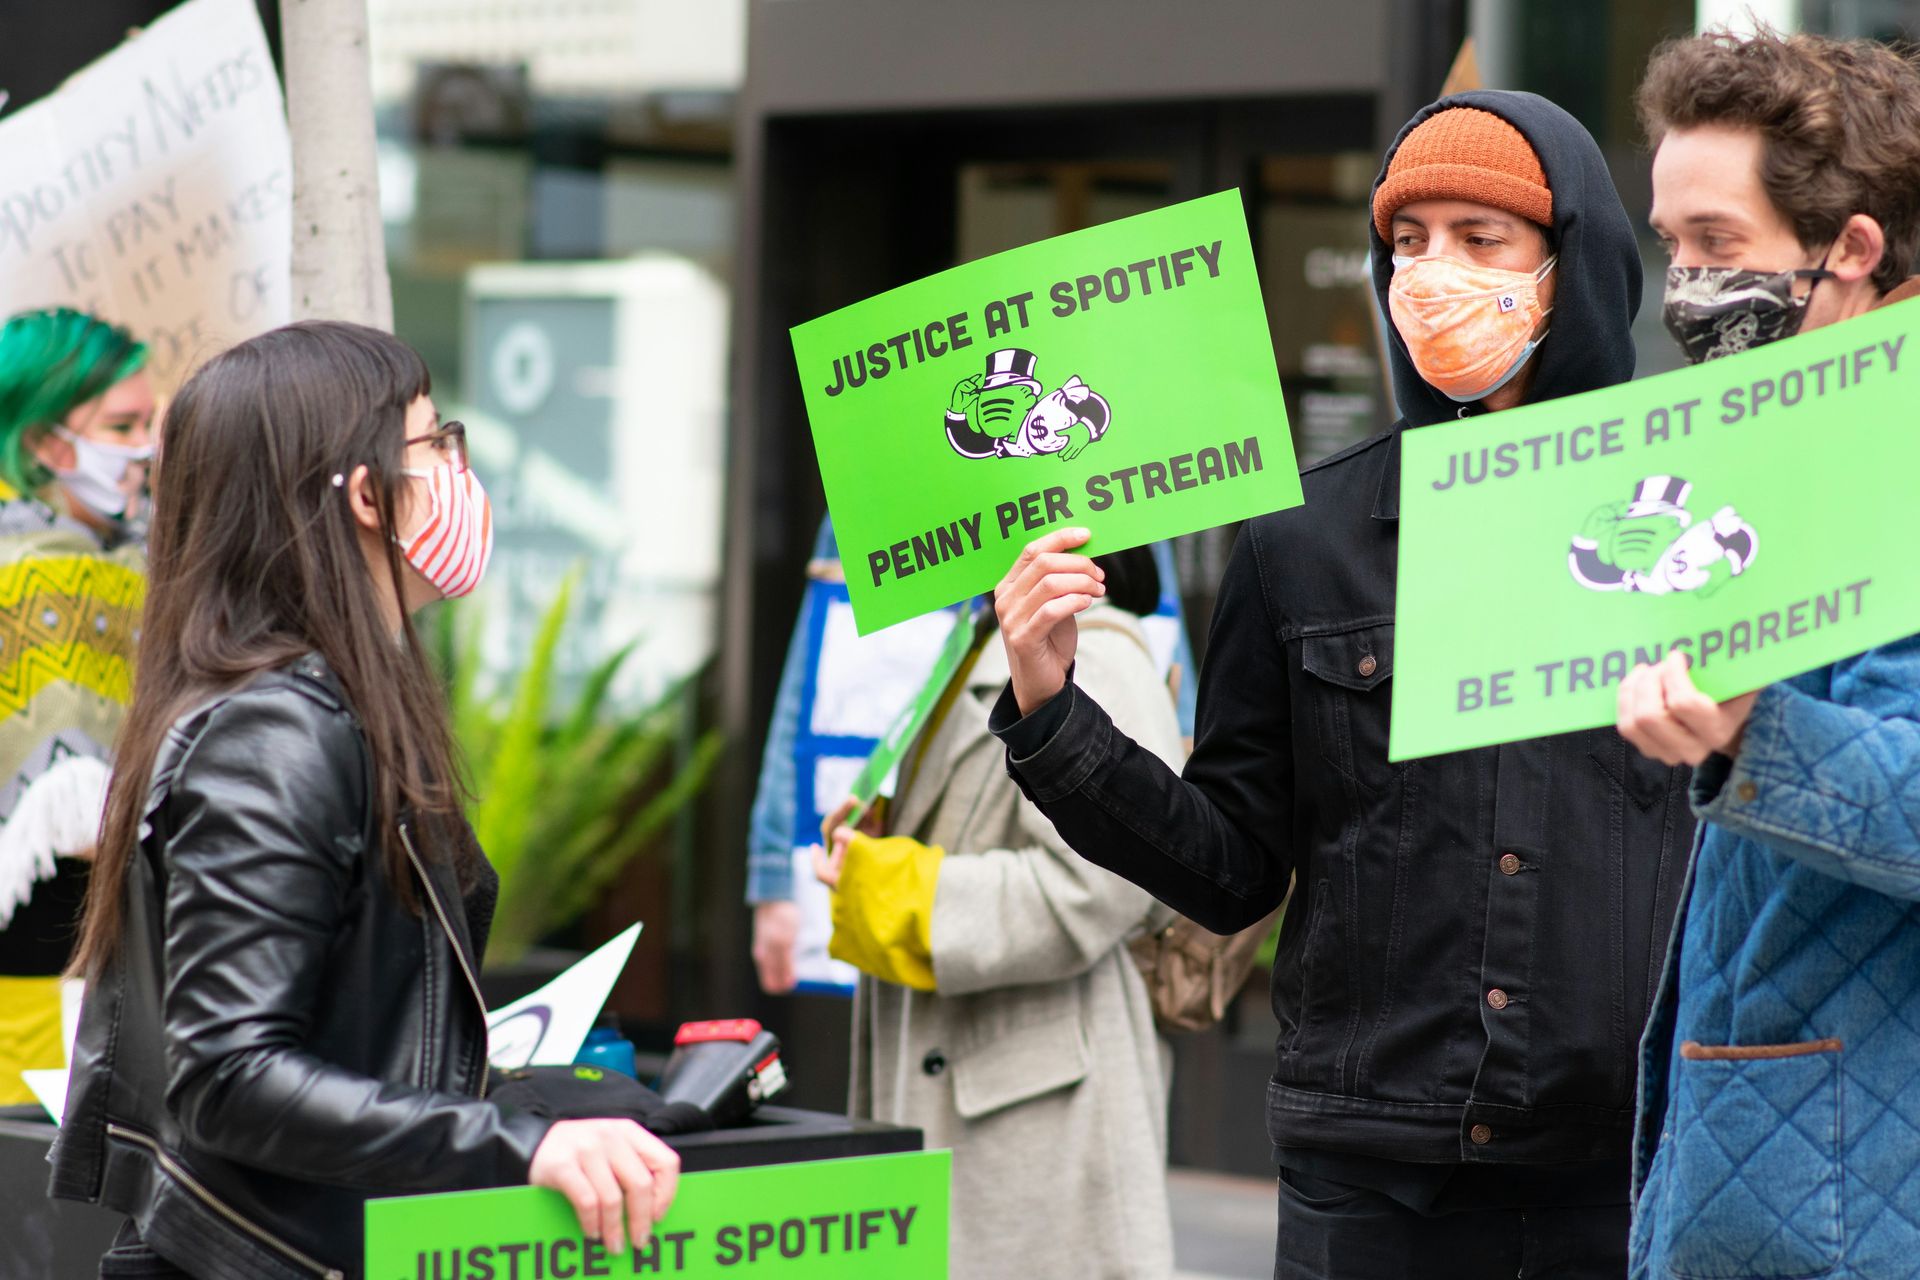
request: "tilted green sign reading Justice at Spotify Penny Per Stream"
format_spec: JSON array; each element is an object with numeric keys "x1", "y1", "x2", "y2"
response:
[{"x1": 793, "y1": 192, "x2": 1300, "y2": 633}]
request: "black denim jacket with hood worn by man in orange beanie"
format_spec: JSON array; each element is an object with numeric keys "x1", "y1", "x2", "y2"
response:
[{"x1": 993, "y1": 92, "x2": 1693, "y2": 1182}]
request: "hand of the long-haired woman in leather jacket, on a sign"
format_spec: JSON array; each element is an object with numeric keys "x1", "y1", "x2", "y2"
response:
[{"x1": 526, "y1": 1121, "x2": 680, "y2": 1253}]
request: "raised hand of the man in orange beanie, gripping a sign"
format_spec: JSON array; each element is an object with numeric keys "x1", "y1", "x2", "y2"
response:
[{"x1": 993, "y1": 530, "x2": 1106, "y2": 716}]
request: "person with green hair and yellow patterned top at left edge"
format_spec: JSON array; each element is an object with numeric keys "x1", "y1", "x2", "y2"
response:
[{"x1": 0, "y1": 309, "x2": 156, "y2": 1103}]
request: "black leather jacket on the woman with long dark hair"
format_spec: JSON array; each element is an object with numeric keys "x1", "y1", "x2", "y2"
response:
[{"x1": 50, "y1": 656, "x2": 549, "y2": 1280}]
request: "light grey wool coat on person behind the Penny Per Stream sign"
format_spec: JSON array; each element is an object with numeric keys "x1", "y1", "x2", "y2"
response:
[{"x1": 851, "y1": 604, "x2": 1181, "y2": 1280}]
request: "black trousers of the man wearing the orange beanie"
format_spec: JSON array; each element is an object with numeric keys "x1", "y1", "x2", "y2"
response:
[{"x1": 1273, "y1": 1171, "x2": 1628, "y2": 1280}]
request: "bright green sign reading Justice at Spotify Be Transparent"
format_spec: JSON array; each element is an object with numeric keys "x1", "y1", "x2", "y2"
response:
[{"x1": 1388, "y1": 303, "x2": 1920, "y2": 760}]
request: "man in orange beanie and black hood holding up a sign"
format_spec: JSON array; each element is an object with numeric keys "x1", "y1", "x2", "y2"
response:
[{"x1": 993, "y1": 92, "x2": 1693, "y2": 1280}]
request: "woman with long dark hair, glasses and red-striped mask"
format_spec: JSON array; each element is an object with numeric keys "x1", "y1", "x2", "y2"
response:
[{"x1": 52, "y1": 322, "x2": 678, "y2": 1280}]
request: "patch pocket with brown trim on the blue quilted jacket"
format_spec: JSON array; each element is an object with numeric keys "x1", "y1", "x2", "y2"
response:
[{"x1": 1667, "y1": 1040, "x2": 1843, "y2": 1280}]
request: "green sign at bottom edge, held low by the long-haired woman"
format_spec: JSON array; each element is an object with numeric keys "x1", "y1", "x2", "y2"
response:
[{"x1": 367, "y1": 1151, "x2": 952, "y2": 1280}]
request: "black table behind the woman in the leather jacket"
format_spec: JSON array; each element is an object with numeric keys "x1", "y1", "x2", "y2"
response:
[{"x1": 0, "y1": 1105, "x2": 924, "y2": 1280}]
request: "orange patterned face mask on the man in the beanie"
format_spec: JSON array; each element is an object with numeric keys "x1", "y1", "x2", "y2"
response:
[{"x1": 1386, "y1": 253, "x2": 1559, "y2": 403}]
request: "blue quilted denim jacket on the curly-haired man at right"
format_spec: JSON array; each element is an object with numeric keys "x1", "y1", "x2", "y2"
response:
[{"x1": 1630, "y1": 637, "x2": 1920, "y2": 1280}]
